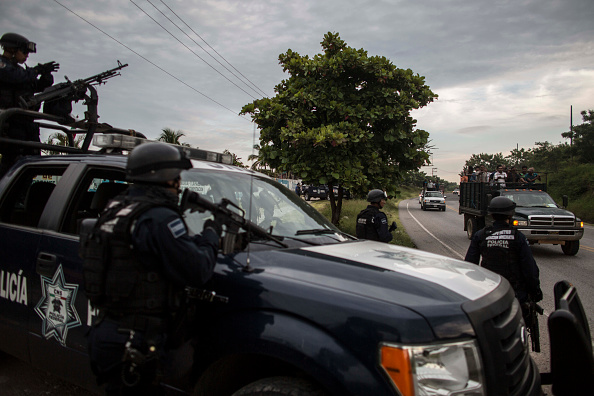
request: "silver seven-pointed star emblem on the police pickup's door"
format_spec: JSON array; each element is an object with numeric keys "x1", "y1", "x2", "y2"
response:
[{"x1": 35, "y1": 265, "x2": 80, "y2": 346}]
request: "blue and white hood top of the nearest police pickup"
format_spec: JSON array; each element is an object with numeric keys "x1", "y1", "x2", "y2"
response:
[{"x1": 252, "y1": 241, "x2": 501, "y2": 307}]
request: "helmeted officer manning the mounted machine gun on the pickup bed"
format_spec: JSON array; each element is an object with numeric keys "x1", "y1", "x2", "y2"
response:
[{"x1": 0, "y1": 33, "x2": 60, "y2": 176}]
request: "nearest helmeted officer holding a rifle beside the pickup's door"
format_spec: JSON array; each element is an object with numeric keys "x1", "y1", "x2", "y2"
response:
[{"x1": 81, "y1": 143, "x2": 222, "y2": 395}]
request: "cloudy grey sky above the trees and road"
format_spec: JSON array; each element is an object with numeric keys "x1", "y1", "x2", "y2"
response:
[{"x1": 0, "y1": 0, "x2": 594, "y2": 182}]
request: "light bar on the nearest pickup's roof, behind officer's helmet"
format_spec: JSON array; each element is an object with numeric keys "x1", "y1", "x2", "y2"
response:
[{"x1": 93, "y1": 134, "x2": 233, "y2": 165}]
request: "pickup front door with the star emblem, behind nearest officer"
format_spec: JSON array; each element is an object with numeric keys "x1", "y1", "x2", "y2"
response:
[{"x1": 30, "y1": 165, "x2": 127, "y2": 389}]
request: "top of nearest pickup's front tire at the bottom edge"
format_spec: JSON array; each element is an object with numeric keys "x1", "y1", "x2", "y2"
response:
[{"x1": 232, "y1": 377, "x2": 327, "y2": 396}]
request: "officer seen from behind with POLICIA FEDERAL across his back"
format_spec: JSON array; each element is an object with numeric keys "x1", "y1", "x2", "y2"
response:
[{"x1": 464, "y1": 197, "x2": 542, "y2": 303}]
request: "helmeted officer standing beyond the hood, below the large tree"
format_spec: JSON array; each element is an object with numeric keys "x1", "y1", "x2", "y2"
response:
[{"x1": 356, "y1": 190, "x2": 396, "y2": 242}]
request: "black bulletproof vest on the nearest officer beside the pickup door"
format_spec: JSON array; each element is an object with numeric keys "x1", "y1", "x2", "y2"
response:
[{"x1": 80, "y1": 200, "x2": 170, "y2": 315}]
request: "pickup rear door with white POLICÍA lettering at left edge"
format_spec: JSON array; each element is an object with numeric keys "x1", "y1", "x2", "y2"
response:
[{"x1": 0, "y1": 166, "x2": 66, "y2": 361}]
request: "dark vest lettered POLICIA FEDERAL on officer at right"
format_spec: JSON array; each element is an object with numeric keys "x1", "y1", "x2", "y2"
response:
[{"x1": 479, "y1": 227, "x2": 525, "y2": 292}]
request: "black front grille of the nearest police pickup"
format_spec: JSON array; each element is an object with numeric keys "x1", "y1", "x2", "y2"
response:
[{"x1": 464, "y1": 282, "x2": 537, "y2": 396}]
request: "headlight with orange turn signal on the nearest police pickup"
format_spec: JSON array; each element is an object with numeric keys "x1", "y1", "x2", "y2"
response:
[{"x1": 380, "y1": 340, "x2": 485, "y2": 396}]
